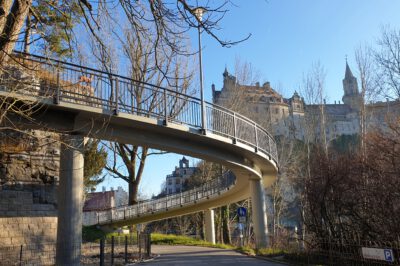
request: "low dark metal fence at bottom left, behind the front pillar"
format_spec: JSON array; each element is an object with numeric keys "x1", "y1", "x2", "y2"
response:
[{"x1": 0, "y1": 233, "x2": 152, "y2": 266}]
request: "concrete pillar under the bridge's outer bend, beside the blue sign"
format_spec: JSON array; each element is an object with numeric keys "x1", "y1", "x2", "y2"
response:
[{"x1": 250, "y1": 179, "x2": 268, "y2": 248}]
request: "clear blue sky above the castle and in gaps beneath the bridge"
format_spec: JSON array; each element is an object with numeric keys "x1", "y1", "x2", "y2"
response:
[{"x1": 104, "y1": 0, "x2": 400, "y2": 196}]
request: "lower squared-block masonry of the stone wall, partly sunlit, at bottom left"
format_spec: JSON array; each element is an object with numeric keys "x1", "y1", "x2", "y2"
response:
[{"x1": 0, "y1": 190, "x2": 57, "y2": 265}]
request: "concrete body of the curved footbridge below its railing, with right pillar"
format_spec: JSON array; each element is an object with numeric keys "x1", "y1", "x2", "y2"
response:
[{"x1": 0, "y1": 87, "x2": 277, "y2": 262}]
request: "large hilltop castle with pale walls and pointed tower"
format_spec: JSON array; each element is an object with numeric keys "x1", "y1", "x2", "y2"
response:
[{"x1": 212, "y1": 62, "x2": 400, "y2": 142}]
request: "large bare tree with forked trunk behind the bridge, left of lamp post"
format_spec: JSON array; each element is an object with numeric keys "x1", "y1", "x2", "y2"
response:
[{"x1": 104, "y1": 28, "x2": 193, "y2": 204}]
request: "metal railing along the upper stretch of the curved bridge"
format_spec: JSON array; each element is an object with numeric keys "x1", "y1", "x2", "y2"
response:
[{"x1": 0, "y1": 53, "x2": 278, "y2": 162}]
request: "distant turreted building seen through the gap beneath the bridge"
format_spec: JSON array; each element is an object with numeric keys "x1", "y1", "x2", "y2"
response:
[{"x1": 165, "y1": 157, "x2": 198, "y2": 194}]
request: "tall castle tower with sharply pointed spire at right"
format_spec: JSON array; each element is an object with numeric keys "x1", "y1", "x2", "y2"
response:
[{"x1": 342, "y1": 60, "x2": 362, "y2": 110}]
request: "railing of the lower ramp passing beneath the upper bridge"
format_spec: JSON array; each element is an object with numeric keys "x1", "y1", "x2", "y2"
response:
[{"x1": 84, "y1": 172, "x2": 236, "y2": 226}]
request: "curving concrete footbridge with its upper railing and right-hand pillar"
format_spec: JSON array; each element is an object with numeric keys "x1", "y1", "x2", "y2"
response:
[{"x1": 0, "y1": 54, "x2": 277, "y2": 264}]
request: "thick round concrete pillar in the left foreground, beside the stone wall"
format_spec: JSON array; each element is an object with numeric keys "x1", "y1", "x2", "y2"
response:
[{"x1": 56, "y1": 135, "x2": 84, "y2": 265}]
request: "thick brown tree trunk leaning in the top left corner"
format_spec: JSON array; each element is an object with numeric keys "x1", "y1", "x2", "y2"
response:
[{"x1": 0, "y1": 0, "x2": 32, "y2": 62}]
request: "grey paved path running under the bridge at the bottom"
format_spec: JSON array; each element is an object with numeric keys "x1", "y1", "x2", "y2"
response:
[{"x1": 145, "y1": 245, "x2": 282, "y2": 266}]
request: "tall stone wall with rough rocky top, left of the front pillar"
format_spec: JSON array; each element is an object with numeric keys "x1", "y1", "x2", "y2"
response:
[{"x1": 0, "y1": 131, "x2": 60, "y2": 265}]
